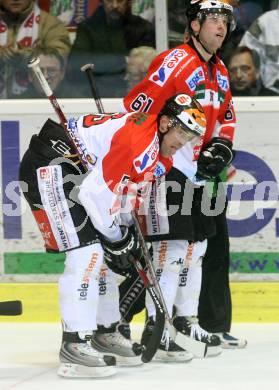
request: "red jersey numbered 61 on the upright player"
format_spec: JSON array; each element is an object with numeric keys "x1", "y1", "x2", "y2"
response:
[{"x1": 122, "y1": 44, "x2": 235, "y2": 149}]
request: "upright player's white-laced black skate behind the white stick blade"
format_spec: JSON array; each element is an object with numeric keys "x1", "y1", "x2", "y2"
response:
[{"x1": 173, "y1": 316, "x2": 222, "y2": 356}]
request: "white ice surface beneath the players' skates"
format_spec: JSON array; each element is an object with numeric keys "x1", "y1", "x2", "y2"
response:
[{"x1": 0, "y1": 323, "x2": 279, "y2": 390}]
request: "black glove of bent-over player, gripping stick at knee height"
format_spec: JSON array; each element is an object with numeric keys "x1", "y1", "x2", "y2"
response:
[{"x1": 101, "y1": 226, "x2": 143, "y2": 273}]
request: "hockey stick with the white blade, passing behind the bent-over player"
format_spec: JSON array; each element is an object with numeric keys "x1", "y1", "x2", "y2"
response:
[{"x1": 81, "y1": 64, "x2": 207, "y2": 357}]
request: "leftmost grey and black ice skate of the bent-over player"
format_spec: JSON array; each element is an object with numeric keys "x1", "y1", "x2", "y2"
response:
[{"x1": 57, "y1": 332, "x2": 116, "y2": 378}]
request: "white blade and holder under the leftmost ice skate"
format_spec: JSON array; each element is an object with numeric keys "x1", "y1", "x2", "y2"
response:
[{"x1": 57, "y1": 363, "x2": 116, "y2": 378}]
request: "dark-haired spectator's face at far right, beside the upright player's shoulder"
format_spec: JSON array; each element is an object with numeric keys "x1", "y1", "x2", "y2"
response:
[{"x1": 228, "y1": 46, "x2": 276, "y2": 96}]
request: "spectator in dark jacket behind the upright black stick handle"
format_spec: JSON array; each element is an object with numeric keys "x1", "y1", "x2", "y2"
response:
[{"x1": 69, "y1": 0, "x2": 155, "y2": 97}]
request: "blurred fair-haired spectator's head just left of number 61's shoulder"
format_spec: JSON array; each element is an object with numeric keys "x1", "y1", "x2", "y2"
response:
[{"x1": 125, "y1": 46, "x2": 156, "y2": 92}]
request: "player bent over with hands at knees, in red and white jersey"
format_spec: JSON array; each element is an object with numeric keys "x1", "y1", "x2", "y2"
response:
[{"x1": 20, "y1": 94, "x2": 206, "y2": 377}]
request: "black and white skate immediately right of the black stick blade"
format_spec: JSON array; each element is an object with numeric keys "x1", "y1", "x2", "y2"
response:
[{"x1": 141, "y1": 318, "x2": 194, "y2": 363}]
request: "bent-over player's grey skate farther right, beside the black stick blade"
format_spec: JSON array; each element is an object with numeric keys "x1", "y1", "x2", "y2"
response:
[{"x1": 91, "y1": 323, "x2": 142, "y2": 366}]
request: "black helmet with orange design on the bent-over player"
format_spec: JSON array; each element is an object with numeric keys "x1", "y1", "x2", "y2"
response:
[{"x1": 159, "y1": 93, "x2": 206, "y2": 137}]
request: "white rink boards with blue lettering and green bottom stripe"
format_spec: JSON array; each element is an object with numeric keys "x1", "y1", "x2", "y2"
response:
[{"x1": 0, "y1": 102, "x2": 279, "y2": 275}]
